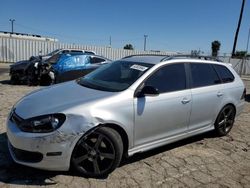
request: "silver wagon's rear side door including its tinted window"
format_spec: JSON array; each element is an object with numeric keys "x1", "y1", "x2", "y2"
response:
[{"x1": 189, "y1": 63, "x2": 224, "y2": 131}]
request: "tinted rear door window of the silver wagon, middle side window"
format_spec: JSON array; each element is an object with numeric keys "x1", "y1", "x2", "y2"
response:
[{"x1": 190, "y1": 63, "x2": 220, "y2": 88}]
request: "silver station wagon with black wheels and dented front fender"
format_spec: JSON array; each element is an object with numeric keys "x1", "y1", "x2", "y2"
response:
[{"x1": 7, "y1": 55, "x2": 246, "y2": 177}]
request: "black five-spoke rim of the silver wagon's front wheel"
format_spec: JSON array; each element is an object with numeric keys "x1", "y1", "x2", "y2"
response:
[{"x1": 72, "y1": 133, "x2": 115, "y2": 175}]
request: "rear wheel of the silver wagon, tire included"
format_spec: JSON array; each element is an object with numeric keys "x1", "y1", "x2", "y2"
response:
[{"x1": 214, "y1": 105, "x2": 236, "y2": 136}]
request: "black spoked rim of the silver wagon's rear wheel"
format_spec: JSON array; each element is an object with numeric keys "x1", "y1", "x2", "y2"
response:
[{"x1": 218, "y1": 106, "x2": 235, "y2": 134}]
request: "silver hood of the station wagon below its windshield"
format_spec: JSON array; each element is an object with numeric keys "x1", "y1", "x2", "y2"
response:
[{"x1": 14, "y1": 81, "x2": 116, "y2": 119}]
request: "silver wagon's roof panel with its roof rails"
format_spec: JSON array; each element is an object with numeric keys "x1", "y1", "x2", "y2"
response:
[{"x1": 122, "y1": 54, "x2": 222, "y2": 64}]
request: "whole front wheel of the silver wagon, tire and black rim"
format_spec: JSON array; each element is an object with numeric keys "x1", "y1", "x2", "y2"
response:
[{"x1": 71, "y1": 127, "x2": 123, "y2": 178}]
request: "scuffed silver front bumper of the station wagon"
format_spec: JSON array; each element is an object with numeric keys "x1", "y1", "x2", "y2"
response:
[{"x1": 7, "y1": 120, "x2": 80, "y2": 171}]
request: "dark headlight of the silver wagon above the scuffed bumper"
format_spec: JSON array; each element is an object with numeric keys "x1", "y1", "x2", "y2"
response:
[{"x1": 19, "y1": 114, "x2": 66, "y2": 133}]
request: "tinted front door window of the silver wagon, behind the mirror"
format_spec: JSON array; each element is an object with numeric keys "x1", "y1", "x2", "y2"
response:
[{"x1": 145, "y1": 63, "x2": 186, "y2": 93}]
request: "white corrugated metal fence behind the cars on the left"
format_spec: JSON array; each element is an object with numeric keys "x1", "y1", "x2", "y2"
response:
[{"x1": 0, "y1": 37, "x2": 175, "y2": 62}]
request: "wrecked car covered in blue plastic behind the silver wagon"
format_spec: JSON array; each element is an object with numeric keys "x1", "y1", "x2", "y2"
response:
[{"x1": 46, "y1": 53, "x2": 111, "y2": 83}]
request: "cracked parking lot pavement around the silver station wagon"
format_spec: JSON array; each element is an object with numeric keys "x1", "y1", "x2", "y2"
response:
[{"x1": 0, "y1": 64, "x2": 250, "y2": 188}]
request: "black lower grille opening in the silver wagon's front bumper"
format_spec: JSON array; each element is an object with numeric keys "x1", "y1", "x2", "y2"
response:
[{"x1": 10, "y1": 144, "x2": 43, "y2": 163}]
